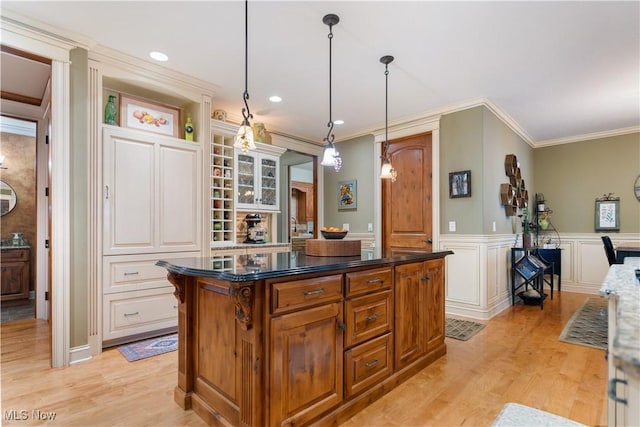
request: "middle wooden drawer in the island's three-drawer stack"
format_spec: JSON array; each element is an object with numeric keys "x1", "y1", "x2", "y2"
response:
[{"x1": 344, "y1": 290, "x2": 393, "y2": 347}]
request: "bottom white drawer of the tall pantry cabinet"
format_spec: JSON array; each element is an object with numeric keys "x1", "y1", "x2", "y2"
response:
[{"x1": 102, "y1": 286, "x2": 178, "y2": 341}]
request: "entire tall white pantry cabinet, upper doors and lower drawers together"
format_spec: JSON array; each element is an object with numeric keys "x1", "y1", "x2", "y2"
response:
[{"x1": 102, "y1": 125, "x2": 202, "y2": 347}]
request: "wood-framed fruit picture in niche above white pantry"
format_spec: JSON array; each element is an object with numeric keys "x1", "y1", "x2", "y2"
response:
[{"x1": 120, "y1": 94, "x2": 180, "y2": 138}]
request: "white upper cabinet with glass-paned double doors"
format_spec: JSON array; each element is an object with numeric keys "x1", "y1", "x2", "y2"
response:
[{"x1": 235, "y1": 144, "x2": 284, "y2": 211}]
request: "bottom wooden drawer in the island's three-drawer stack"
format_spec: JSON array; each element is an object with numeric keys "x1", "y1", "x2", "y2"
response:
[{"x1": 344, "y1": 333, "x2": 393, "y2": 397}]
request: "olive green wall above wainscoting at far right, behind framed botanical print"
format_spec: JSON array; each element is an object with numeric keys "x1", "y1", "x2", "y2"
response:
[{"x1": 534, "y1": 133, "x2": 640, "y2": 233}]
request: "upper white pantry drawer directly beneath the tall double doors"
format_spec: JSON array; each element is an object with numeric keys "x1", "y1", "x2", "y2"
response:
[{"x1": 102, "y1": 252, "x2": 200, "y2": 295}]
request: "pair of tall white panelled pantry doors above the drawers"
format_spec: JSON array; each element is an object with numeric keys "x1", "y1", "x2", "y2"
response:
[{"x1": 103, "y1": 126, "x2": 202, "y2": 255}]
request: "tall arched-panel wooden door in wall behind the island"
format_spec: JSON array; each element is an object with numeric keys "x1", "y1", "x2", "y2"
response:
[{"x1": 382, "y1": 133, "x2": 432, "y2": 254}]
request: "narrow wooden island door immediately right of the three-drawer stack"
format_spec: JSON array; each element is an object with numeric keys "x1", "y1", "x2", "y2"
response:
[{"x1": 394, "y1": 262, "x2": 427, "y2": 369}]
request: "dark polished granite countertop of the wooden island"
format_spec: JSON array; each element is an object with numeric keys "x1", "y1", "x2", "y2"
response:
[{"x1": 156, "y1": 251, "x2": 453, "y2": 282}]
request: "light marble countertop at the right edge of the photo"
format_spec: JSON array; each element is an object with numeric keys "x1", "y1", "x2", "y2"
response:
[{"x1": 600, "y1": 258, "x2": 640, "y2": 377}]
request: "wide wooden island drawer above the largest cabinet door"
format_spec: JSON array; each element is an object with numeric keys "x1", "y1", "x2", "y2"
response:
[{"x1": 271, "y1": 274, "x2": 342, "y2": 314}]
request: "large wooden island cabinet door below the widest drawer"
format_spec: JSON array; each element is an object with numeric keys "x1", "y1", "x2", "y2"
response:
[{"x1": 269, "y1": 303, "x2": 344, "y2": 426}]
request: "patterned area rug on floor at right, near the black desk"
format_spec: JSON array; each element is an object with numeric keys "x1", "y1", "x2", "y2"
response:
[{"x1": 559, "y1": 298, "x2": 608, "y2": 350}]
